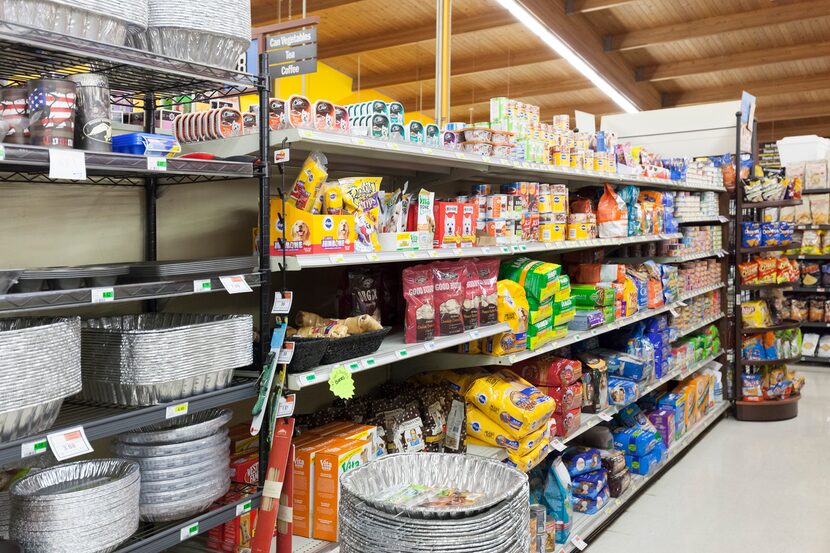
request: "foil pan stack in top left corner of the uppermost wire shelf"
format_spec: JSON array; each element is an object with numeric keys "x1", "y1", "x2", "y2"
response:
[{"x1": 0, "y1": 0, "x2": 149, "y2": 45}]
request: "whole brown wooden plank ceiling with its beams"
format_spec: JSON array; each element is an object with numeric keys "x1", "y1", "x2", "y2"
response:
[{"x1": 251, "y1": 0, "x2": 830, "y2": 140}]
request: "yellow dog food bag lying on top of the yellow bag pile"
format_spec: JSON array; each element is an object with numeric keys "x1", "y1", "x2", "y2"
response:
[{"x1": 465, "y1": 369, "x2": 556, "y2": 439}]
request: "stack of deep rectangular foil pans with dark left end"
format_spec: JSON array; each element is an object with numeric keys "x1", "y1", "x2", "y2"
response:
[{"x1": 81, "y1": 313, "x2": 253, "y2": 406}]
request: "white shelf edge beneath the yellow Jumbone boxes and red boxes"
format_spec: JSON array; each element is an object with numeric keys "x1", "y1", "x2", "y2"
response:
[{"x1": 271, "y1": 233, "x2": 683, "y2": 271}]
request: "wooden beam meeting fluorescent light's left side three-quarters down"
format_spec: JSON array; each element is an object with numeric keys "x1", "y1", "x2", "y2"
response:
[{"x1": 401, "y1": 79, "x2": 594, "y2": 111}]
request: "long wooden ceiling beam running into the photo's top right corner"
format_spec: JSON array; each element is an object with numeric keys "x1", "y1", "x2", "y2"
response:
[{"x1": 605, "y1": 0, "x2": 830, "y2": 50}]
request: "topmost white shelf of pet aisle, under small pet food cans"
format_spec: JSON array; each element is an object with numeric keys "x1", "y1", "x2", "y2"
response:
[{"x1": 184, "y1": 129, "x2": 725, "y2": 192}]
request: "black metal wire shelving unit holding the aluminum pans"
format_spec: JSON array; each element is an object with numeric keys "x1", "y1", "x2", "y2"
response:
[{"x1": 0, "y1": 21, "x2": 271, "y2": 553}]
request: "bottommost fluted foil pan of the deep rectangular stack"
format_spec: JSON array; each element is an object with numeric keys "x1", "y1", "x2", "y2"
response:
[{"x1": 78, "y1": 369, "x2": 233, "y2": 407}]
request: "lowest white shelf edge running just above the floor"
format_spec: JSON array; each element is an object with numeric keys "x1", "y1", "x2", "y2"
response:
[{"x1": 556, "y1": 401, "x2": 729, "y2": 553}]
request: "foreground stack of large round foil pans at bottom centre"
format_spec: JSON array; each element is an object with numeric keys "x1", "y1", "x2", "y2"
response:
[{"x1": 339, "y1": 453, "x2": 530, "y2": 553}]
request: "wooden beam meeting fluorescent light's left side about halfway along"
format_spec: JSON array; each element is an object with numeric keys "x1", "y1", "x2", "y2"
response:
[{"x1": 353, "y1": 48, "x2": 565, "y2": 90}]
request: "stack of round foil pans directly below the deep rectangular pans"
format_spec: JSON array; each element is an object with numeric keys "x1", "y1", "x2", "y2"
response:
[{"x1": 115, "y1": 409, "x2": 233, "y2": 522}]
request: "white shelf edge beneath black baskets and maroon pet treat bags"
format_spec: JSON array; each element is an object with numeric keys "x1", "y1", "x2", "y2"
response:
[{"x1": 286, "y1": 323, "x2": 510, "y2": 390}]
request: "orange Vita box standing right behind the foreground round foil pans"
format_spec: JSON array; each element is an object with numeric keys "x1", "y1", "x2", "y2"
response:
[{"x1": 314, "y1": 439, "x2": 373, "y2": 541}]
